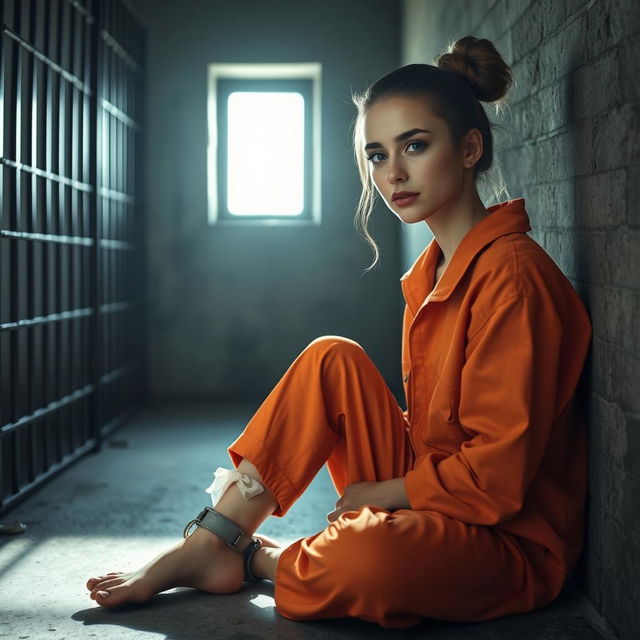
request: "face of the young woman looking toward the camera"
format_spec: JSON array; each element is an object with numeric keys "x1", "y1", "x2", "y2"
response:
[{"x1": 364, "y1": 97, "x2": 464, "y2": 223}]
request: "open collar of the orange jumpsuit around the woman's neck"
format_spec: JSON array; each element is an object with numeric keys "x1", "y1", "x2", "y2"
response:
[{"x1": 400, "y1": 198, "x2": 531, "y2": 315}]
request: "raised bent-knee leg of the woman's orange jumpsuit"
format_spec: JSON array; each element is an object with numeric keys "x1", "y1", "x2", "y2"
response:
[{"x1": 228, "y1": 336, "x2": 413, "y2": 517}]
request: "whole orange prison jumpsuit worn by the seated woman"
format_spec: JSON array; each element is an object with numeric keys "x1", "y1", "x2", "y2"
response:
[{"x1": 228, "y1": 198, "x2": 591, "y2": 628}]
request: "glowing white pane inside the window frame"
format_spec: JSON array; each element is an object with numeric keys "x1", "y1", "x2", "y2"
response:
[{"x1": 227, "y1": 91, "x2": 304, "y2": 216}]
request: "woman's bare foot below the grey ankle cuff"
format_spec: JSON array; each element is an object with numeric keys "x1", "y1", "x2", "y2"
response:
[{"x1": 86, "y1": 527, "x2": 250, "y2": 607}]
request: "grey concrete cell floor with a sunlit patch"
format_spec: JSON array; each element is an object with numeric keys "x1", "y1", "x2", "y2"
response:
[{"x1": 0, "y1": 405, "x2": 614, "y2": 640}]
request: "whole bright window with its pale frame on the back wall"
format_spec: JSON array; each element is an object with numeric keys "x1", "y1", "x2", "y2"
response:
[{"x1": 207, "y1": 63, "x2": 321, "y2": 224}]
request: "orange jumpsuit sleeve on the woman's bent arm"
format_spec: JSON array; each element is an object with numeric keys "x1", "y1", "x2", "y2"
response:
[{"x1": 404, "y1": 294, "x2": 562, "y2": 525}]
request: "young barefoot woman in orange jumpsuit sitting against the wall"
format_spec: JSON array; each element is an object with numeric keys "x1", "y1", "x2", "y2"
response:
[{"x1": 87, "y1": 36, "x2": 591, "y2": 628}]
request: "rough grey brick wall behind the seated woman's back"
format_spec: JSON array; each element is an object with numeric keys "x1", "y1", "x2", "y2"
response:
[{"x1": 401, "y1": 0, "x2": 640, "y2": 639}]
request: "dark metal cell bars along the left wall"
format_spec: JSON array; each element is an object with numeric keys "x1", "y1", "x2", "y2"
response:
[{"x1": 0, "y1": 0, "x2": 147, "y2": 514}]
